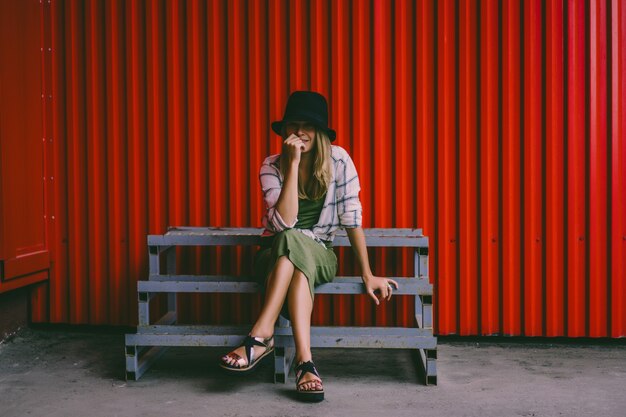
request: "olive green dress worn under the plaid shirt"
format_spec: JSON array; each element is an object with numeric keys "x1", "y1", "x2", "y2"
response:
[{"x1": 254, "y1": 195, "x2": 337, "y2": 319}]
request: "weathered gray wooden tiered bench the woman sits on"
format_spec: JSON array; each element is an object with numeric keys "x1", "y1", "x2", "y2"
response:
[{"x1": 126, "y1": 227, "x2": 437, "y2": 385}]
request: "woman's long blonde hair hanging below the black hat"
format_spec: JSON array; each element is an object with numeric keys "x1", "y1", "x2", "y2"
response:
[{"x1": 280, "y1": 128, "x2": 332, "y2": 200}]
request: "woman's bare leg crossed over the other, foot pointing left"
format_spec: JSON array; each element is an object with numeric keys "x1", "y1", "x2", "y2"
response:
[{"x1": 222, "y1": 256, "x2": 295, "y2": 365}]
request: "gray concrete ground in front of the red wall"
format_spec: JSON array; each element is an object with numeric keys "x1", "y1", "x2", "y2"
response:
[{"x1": 0, "y1": 329, "x2": 626, "y2": 417}]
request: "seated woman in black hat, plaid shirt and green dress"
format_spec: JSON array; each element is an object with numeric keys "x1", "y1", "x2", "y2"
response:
[{"x1": 220, "y1": 91, "x2": 398, "y2": 401}]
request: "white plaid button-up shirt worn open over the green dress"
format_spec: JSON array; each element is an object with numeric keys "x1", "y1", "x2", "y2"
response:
[{"x1": 259, "y1": 145, "x2": 362, "y2": 247}]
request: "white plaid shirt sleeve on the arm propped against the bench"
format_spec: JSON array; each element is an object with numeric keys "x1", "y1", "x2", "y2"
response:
[{"x1": 335, "y1": 152, "x2": 363, "y2": 228}]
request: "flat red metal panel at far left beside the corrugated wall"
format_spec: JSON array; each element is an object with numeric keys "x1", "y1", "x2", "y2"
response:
[{"x1": 0, "y1": 0, "x2": 51, "y2": 293}]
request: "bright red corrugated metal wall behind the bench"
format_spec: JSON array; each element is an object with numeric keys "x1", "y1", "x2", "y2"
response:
[{"x1": 22, "y1": 0, "x2": 626, "y2": 337}]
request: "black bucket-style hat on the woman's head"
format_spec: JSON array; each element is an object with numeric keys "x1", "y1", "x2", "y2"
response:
[{"x1": 272, "y1": 91, "x2": 337, "y2": 142}]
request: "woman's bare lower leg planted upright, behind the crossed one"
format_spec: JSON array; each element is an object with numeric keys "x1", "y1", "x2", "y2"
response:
[{"x1": 287, "y1": 269, "x2": 322, "y2": 390}]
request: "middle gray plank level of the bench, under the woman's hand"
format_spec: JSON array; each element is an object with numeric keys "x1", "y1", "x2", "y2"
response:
[{"x1": 137, "y1": 275, "x2": 432, "y2": 295}]
